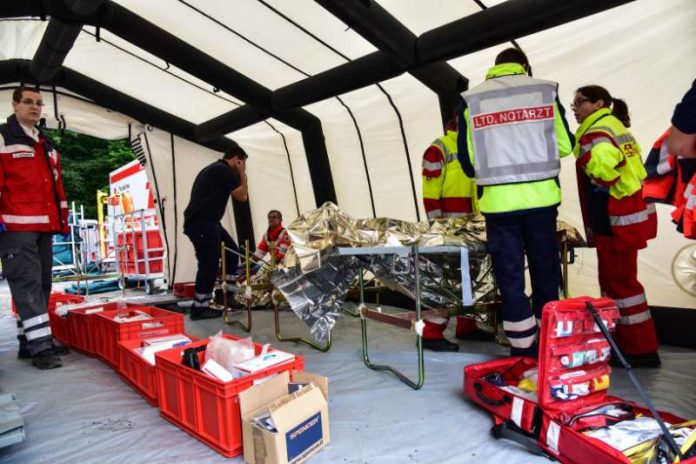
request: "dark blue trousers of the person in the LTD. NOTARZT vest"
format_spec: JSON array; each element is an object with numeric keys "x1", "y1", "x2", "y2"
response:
[{"x1": 486, "y1": 207, "x2": 561, "y2": 356}]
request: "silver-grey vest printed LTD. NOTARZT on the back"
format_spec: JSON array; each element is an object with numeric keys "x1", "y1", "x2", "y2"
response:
[{"x1": 462, "y1": 75, "x2": 561, "y2": 185}]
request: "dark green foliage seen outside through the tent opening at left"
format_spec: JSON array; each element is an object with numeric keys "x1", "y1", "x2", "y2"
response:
[{"x1": 48, "y1": 130, "x2": 135, "y2": 219}]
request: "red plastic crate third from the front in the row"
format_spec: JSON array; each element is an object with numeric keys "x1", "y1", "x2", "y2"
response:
[{"x1": 95, "y1": 306, "x2": 184, "y2": 370}]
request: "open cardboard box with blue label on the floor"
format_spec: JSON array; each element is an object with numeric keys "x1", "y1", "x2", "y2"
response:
[{"x1": 239, "y1": 371, "x2": 330, "y2": 464}]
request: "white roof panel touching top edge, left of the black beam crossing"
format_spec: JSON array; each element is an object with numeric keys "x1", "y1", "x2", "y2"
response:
[{"x1": 112, "y1": 0, "x2": 375, "y2": 89}]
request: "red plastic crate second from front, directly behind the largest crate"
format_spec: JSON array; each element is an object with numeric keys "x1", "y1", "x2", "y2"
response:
[{"x1": 118, "y1": 334, "x2": 198, "y2": 407}]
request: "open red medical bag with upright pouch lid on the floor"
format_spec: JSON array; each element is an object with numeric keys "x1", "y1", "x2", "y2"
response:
[{"x1": 464, "y1": 297, "x2": 696, "y2": 464}]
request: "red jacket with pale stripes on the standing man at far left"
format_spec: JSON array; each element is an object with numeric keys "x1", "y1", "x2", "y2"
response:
[{"x1": 0, "y1": 115, "x2": 69, "y2": 234}]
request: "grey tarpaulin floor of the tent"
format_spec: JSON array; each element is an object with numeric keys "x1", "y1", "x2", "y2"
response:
[{"x1": 0, "y1": 283, "x2": 696, "y2": 464}]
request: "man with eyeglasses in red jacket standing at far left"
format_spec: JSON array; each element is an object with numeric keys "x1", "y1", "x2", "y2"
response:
[{"x1": 0, "y1": 87, "x2": 69, "y2": 369}]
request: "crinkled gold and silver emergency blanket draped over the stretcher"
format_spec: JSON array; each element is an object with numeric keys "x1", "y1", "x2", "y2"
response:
[{"x1": 271, "y1": 203, "x2": 584, "y2": 341}]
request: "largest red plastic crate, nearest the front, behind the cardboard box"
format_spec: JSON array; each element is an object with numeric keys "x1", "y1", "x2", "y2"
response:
[{"x1": 155, "y1": 335, "x2": 304, "y2": 457}]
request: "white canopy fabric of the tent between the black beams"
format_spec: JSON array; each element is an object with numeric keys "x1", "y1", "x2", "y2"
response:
[{"x1": 0, "y1": 0, "x2": 696, "y2": 308}]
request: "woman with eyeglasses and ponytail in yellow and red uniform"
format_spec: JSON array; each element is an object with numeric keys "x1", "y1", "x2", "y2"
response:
[{"x1": 571, "y1": 85, "x2": 660, "y2": 367}]
